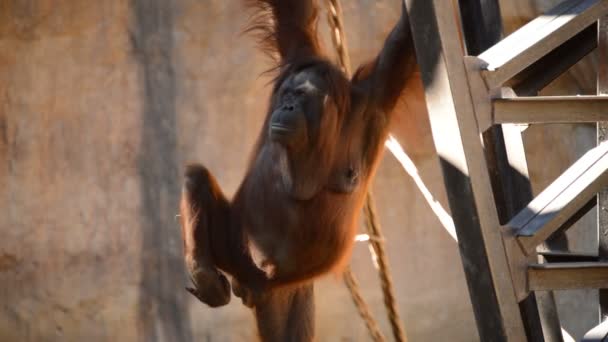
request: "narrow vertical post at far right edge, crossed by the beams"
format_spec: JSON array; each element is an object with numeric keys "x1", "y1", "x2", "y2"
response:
[{"x1": 597, "y1": 16, "x2": 608, "y2": 322}]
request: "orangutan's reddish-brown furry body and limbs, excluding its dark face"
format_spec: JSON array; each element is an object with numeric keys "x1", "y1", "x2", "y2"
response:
[{"x1": 180, "y1": 0, "x2": 415, "y2": 341}]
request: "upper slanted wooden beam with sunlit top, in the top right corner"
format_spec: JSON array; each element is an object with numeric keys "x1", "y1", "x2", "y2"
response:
[{"x1": 477, "y1": 0, "x2": 608, "y2": 89}]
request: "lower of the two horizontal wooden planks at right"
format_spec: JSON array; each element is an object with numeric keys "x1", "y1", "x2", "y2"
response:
[{"x1": 528, "y1": 262, "x2": 608, "y2": 291}]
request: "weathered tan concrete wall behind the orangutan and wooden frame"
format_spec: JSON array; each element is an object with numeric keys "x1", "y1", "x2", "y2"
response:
[{"x1": 0, "y1": 0, "x2": 594, "y2": 342}]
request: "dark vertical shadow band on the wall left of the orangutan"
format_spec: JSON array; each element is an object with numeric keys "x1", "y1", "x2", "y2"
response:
[{"x1": 131, "y1": 0, "x2": 192, "y2": 341}]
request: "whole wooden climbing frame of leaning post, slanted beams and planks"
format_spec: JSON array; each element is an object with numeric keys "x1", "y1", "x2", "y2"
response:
[{"x1": 406, "y1": 0, "x2": 608, "y2": 342}]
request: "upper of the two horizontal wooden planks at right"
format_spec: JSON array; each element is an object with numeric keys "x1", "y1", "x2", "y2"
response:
[{"x1": 492, "y1": 95, "x2": 608, "y2": 124}]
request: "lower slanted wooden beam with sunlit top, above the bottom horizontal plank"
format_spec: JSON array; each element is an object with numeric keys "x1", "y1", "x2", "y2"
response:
[{"x1": 506, "y1": 142, "x2": 608, "y2": 254}]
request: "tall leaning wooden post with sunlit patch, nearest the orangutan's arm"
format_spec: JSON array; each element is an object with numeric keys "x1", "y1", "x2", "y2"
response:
[{"x1": 407, "y1": 0, "x2": 526, "y2": 341}]
